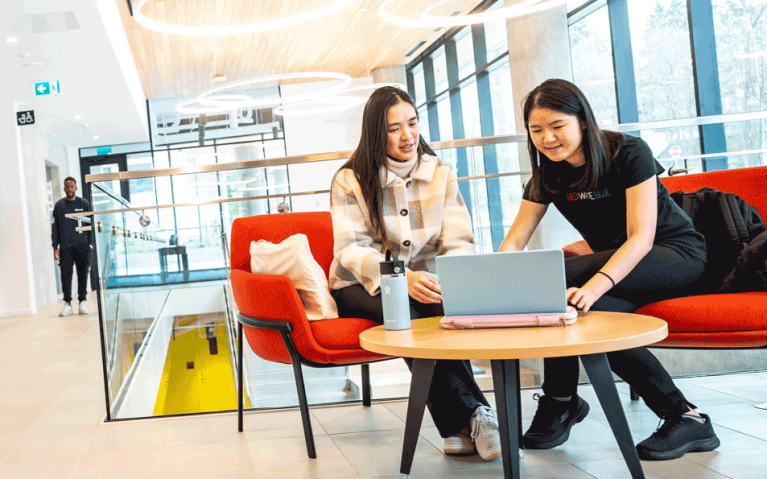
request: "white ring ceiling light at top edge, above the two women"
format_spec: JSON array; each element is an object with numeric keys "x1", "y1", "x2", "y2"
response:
[{"x1": 378, "y1": 0, "x2": 568, "y2": 28}]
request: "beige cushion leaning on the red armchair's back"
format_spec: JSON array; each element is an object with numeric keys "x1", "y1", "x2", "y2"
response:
[{"x1": 250, "y1": 234, "x2": 338, "y2": 321}]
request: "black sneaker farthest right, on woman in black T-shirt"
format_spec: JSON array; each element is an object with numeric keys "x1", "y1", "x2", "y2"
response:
[{"x1": 637, "y1": 414, "x2": 719, "y2": 461}]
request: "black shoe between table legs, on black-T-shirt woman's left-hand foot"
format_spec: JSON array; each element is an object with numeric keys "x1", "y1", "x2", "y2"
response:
[{"x1": 522, "y1": 394, "x2": 589, "y2": 449}]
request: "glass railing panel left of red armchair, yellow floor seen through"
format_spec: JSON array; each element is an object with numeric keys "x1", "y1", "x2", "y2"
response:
[{"x1": 84, "y1": 184, "x2": 249, "y2": 419}]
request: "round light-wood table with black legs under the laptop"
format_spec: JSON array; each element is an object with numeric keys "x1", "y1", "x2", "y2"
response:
[{"x1": 360, "y1": 311, "x2": 668, "y2": 478}]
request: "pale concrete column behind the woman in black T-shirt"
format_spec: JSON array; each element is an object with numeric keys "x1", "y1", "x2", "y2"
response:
[{"x1": 504, "y1": 0, "x2": 581, "y2": 249}]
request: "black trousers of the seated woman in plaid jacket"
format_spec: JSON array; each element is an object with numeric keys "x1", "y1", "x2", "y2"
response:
[{"x1": 331, "y1": 284, "x2": 489, "y2": 437}]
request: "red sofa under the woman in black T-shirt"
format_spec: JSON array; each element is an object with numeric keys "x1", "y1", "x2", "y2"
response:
[{"x1": 563, "y1": 166, "x2": 767, "y2": 348}]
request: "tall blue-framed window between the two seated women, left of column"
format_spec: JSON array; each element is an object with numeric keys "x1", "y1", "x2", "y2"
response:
[{"x1": 408, "y1": 0, "x2": 519, "y2": 251}]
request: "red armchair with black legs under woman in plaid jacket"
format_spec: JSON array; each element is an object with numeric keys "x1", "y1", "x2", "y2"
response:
[{"x1": 231, "y1": 212, "x2": 389, "y2": 458}]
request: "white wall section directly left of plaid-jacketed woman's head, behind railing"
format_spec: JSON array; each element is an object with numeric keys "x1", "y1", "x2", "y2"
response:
[{"x1": 281, "y1": 78, "x2": 373, "y2": 211}]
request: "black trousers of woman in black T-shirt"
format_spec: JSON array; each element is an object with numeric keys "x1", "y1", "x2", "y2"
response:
[{"x1": 543, "y1": 245, "x2": 704, "y2": 418}]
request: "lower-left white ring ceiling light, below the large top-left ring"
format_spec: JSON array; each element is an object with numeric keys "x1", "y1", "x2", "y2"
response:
[{"x1": 176, "y1": 72, "x2": 352, "y2": 115}]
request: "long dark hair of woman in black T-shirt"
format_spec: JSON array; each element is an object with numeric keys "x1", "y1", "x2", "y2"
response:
[{"x1": 522, "y1": 79, "x2": 622, "y2": 199}]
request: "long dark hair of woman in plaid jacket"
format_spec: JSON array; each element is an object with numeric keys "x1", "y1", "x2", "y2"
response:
[{"x1": 331, "y1": 86, "x2": 434, "y2": 249}]
